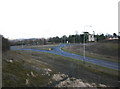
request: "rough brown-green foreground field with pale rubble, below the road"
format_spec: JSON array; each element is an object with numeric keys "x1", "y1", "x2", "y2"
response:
[{"x1": 2, "y1": 48, "x2": 118, "y2": 87}]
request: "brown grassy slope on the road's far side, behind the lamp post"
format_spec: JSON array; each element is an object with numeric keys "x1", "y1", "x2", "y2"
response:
[{"x1": 62, "y1": 40, "x2": 118, "y2": 62}]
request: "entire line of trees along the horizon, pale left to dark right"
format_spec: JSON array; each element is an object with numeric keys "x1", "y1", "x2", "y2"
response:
[{"x1": 11, "y1": 32, "x2": 117, "y2": 45}]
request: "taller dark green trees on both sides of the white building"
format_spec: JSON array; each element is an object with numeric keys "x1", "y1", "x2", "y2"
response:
[{"x1": 48, "y1": 32, "x2": 107, "y2": 43}]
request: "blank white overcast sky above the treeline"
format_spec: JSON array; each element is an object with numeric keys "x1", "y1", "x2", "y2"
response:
[{"x1": 0, "y1": 0, "x2": 120, "y2": 39}]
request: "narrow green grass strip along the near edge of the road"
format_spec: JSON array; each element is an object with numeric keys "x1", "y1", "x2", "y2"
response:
[{"x1": 47, "y1": 53, "x2": 120, "y2": 77}]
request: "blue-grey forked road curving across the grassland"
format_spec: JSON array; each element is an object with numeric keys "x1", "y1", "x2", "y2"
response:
[{"x1": 11, "y1": 44, "x2": 120, "y2": 70}]
